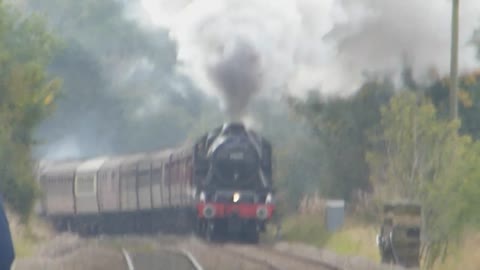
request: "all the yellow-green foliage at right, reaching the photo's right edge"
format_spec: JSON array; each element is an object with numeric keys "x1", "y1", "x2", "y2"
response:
[{"x1": 366, "y1": 91, "x2": 480, "y2": 267}]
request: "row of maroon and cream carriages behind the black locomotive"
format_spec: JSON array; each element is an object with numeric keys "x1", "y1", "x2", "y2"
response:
[{"x1": 38, "y1": 143, "x2": 210, "y2": 234}]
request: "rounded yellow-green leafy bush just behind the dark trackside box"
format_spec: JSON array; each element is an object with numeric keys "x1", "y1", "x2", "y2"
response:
[{"x1": 367, "y1": 92, "x2": 459, "y2": 200}]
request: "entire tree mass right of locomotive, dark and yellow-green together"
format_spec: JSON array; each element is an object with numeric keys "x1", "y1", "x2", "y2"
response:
[{"x1": 289, "y1": 73, "x2": 480, "y2": 267}]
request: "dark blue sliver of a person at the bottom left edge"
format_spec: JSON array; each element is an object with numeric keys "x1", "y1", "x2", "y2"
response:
[{"x1": 0, "y1": 197, "x2": 15, "y2": 270}]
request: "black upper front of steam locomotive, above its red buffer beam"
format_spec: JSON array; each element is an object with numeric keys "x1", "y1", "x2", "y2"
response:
[{"x1": 195, "y1": 121, "x2": 271, "y2": 192}]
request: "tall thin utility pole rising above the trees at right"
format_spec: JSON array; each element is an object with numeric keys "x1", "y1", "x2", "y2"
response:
[{"x1": 450, "y1": 0, "x2": 460, "y2": 120}]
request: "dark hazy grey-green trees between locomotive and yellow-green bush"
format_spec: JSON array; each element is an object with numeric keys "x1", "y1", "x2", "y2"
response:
[{"x1": 290, "y1": 80, "x2": 393, "y2": 199}]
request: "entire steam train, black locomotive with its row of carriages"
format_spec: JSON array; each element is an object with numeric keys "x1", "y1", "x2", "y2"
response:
[{"x1": 37, "y1": 123, "x2": 275, "y2": 242}]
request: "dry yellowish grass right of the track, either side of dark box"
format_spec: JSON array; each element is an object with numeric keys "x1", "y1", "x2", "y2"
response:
[{"x1": 282, "y1": 215, "x2": 480, "y2": 270}]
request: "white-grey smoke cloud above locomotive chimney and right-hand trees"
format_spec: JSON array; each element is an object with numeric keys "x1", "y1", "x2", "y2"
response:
[{"x1": 141, "y1": 0, "x2": 480, "y2": 117}]
